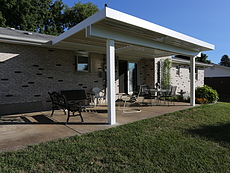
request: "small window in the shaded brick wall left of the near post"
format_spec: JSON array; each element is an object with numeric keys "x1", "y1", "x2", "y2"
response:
[{"x1": 75, "y1": 55, "x2": 90, "y2": 72}]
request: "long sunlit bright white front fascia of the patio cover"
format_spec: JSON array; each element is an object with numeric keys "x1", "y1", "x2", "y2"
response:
[{"x1": 106, "y1": 7, "x2": 215, "y2": 50}]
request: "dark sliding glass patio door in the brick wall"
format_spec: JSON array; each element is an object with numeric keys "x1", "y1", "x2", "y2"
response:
[{"x1": 119, "y1": 60, "x2": 137, "y2": 94}]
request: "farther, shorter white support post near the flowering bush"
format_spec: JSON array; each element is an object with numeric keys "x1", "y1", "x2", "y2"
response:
[{"x1": 190, "y1": 53, "x2": 200, "y2": 106}]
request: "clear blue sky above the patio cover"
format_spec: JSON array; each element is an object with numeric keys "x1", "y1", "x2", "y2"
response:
[{"x1": 63, "y1": 0, "x2": 230, "y2": 63}]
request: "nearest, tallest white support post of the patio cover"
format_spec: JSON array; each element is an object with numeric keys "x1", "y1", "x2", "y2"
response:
[{"x1": 106, "y1": 39, "x2": 116, "y2": 125}]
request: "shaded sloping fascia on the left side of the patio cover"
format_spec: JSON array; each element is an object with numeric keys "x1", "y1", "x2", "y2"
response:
[{"x1": 52, "y1": 8, "x2": 106, "y2": 45}]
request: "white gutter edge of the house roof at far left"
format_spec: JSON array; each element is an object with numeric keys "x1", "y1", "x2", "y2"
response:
[{"x1": 0, "y1": 34, "x2": 49, "y2": 44}]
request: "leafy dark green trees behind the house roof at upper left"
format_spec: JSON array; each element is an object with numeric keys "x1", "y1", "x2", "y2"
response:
[{"x1": 0, "y1": 0, "x2": 99, "y2": 35}]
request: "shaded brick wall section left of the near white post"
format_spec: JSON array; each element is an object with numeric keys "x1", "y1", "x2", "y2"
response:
[{"x1": 0, "y1": 43, "x2": 105, "y2": 114}]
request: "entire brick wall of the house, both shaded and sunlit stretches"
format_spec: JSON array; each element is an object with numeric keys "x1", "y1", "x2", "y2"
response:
[{"x1": 0, "y1": 40, "x2": 207, "y2": 115}]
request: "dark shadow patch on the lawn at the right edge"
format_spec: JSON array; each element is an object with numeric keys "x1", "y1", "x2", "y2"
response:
[{"x1": 188, "y1": 123, "x2": 230, "y2": 143}]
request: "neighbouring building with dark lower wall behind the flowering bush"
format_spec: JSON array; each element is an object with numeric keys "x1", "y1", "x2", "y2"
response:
[{"x1": 204, "y1": 64, "x2": 230, "y2": 96}]
